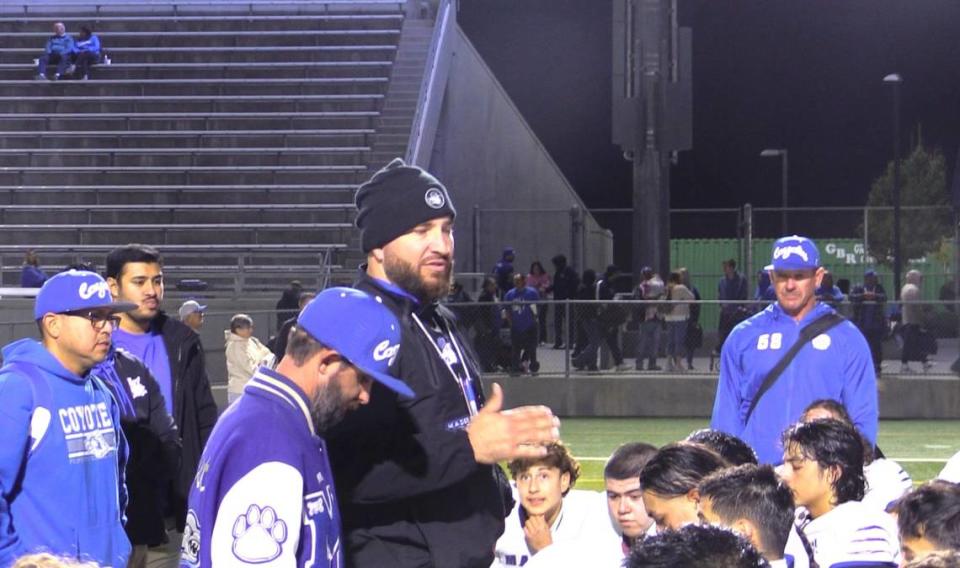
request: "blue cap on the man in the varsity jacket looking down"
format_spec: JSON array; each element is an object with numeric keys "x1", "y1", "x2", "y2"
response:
[{"x1": 297, "y1": 287, "x2": 414, "y2": 398}]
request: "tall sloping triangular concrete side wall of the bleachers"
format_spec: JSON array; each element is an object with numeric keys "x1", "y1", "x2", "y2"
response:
[{"x1": 429, "y1": 26, "x2": 613, "y2": 272}]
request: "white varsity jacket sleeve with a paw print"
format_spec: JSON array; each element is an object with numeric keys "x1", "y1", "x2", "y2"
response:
[{"x1": 210, "y1": 461, "x2": 303, "y2": 568}]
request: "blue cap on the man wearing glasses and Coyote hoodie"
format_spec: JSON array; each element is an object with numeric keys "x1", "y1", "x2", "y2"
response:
[{"x1": 33, "y1": 270, "x2": 137, "y2": 319}]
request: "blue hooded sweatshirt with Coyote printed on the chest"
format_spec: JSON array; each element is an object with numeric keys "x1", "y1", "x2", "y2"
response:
[{"x1": 0, "y1": 339, "x2": 130, "y2": 567}]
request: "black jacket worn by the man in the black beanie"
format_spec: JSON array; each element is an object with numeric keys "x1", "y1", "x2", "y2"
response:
[{"x1": 326, "y1": 274, "x2": 512, "y2": 568}]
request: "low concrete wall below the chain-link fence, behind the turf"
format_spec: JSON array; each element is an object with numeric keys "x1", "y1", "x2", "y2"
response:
[{"x1": 484, "y1": 376, "x2": 960, "y2": 419}]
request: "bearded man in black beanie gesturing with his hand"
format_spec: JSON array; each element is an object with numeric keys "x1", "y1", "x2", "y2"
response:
[{"x1": 328, "y1": 158, "x2": 559, "y2": 568}]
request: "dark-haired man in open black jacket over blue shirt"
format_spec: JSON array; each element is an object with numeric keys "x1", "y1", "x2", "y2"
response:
[{"x1": 107, "y1": 244, "x2": 217, "y2": 554}]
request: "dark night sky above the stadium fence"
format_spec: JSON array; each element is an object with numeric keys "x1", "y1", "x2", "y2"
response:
[{"x1": 459, "y1": 0, "x2": 960, "y2": 230}]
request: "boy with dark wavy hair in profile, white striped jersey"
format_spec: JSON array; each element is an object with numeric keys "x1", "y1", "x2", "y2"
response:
[{"x1": 780, "y1": 419, "x2": 900, "y2": 567}]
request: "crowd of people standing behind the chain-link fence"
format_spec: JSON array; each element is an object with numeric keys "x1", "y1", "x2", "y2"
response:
[{"x1": 422, "y1": 246, "x2": 936, "y2": 380}]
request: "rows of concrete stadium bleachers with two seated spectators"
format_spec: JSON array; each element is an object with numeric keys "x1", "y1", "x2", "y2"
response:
[{"x1": 0, "y1": 0, "x2": 433, "y2": 294}]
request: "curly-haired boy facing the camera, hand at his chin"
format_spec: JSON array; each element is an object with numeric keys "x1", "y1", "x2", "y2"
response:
[{"x1": 493, "y1": 442, "x2": 599, "y2": 566}]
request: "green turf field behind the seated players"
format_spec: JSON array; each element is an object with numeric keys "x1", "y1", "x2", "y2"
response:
[{"x1": 560, "y1": 418, "x2": 960, "y2": 489}]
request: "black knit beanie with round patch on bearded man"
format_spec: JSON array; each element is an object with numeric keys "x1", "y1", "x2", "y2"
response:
[{"x1": 356, "y1": 158, "x2": 457, "y2": 253}]
